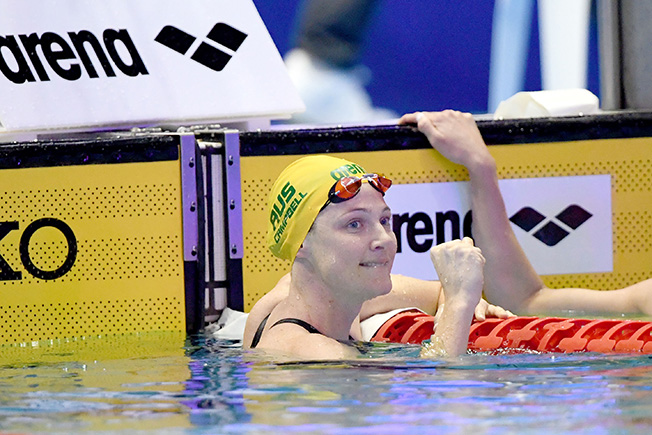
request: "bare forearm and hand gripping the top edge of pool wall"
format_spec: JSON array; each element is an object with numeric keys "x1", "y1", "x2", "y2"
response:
[{"x1": 400, "y1": 110, "x2": 544, "y2": 314}]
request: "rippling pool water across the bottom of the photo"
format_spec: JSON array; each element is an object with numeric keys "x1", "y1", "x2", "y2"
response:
[{"x1": 0, "y1": 335, "x2": 652, "y2": 435}]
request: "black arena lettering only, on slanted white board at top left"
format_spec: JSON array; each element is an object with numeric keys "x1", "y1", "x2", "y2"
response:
[{"x1": 0, "y1": 29, "x2": 148, "y2": 84}]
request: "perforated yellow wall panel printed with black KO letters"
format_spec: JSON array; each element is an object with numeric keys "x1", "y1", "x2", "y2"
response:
[{"x1": 0, "y1": 161, "x2": 185, "y2": 344}]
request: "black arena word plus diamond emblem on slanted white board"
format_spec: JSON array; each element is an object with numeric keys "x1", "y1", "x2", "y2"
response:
[{"x1": 0, "y1": 23, "x2": 247, "y2": 84}]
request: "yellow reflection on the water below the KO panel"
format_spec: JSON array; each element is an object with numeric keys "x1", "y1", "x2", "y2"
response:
[{"x1": 0, "y1": 333, "x2": 191, "y2": 433}]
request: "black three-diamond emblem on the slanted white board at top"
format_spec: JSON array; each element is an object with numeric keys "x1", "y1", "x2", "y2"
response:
[{"x1": 154, "y1": 23, "x2": 247, "y2": 71}]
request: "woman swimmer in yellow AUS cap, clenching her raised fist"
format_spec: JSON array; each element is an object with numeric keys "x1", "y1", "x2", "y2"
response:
[{"x1": 251, "y1": 155, "x2": 484, "y2": 360}]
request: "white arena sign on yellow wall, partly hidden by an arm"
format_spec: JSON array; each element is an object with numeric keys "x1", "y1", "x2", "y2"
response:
[{"x1": 385, "y1": 175, "x2": 613, "y2": 279}]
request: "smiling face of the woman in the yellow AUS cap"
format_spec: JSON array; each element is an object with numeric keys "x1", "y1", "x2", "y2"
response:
[{"x1": 301, "y1": 182, "x2": 396, "y2": 300}]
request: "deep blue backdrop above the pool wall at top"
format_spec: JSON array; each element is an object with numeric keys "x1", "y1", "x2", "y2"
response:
[{"x1": 254, "y1": 0, "x2": 600, "y2": 114}]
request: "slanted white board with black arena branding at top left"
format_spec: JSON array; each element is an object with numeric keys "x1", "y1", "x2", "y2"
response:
[{"x1": 0, "y1": 0, "x2": 303, "y2": 131}]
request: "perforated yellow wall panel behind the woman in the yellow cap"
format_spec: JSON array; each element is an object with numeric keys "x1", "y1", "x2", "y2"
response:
[{"x1": 241, "y1": 138, "x2": 652, "y2": 310}]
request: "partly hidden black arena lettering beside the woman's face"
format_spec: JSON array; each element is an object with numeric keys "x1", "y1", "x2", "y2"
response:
[{"x1": 392, "y1": 210, "x2": 473, "y2": 253}]
